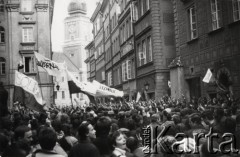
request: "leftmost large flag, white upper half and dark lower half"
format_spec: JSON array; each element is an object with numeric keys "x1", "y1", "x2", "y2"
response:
[{"x1": 14, "y1": 71, "x2": 45, "y2": 112}]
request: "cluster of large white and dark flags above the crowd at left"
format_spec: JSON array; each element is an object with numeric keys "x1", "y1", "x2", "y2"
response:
[{"x1": 14, "y1": 52, "x2": 124, "y2": 112}]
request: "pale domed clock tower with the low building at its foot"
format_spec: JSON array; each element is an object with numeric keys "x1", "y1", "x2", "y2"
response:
[{"x1": 53, "y1": 0, "x2": 92, "y2": 106}]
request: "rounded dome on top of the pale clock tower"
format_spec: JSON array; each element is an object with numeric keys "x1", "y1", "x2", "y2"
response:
[{"x1": 68, "y1": 0, "x2": 87, "y2": 15}]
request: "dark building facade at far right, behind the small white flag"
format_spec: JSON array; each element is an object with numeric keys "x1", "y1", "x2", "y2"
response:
[{"x1": 170, "y1": 0, "x2": 240, "y2": 99}]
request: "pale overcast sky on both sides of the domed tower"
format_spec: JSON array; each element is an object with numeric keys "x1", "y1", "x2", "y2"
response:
[{"x1": 51, "y1": 0, "x2": 99, "y2": 52}]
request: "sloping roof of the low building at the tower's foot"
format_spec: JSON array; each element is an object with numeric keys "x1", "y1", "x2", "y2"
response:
[{"x1": 52, "y1": 52, "x2": 79, "y2": 72}]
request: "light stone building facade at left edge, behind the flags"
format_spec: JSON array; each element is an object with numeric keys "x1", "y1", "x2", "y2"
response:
[{"x1": 0, "y1": 0, "x2": 54, "y2": 106}]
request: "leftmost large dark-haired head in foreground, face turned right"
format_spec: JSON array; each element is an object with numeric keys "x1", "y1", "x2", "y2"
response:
[{"x1": 14, "y1": 125, "x2": 33, "y2": 143}]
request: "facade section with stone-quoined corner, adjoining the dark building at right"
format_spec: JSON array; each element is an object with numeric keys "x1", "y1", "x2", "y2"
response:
[{"x1": 133, "y1": 0, "x2": 176, "y2": 99}]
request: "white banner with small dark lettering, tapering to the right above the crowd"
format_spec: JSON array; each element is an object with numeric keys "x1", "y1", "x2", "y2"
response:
[{"x1": 92, "y1": 80, "x2": 124, "y2": 97}]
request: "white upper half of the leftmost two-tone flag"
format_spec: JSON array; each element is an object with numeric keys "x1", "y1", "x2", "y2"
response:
[{"x1": 14, "y1": 71, "x2": 45, "y2": 105}]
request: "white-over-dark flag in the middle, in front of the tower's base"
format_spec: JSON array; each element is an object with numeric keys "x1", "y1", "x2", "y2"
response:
[{"x1": 66, "y1": 70, "x2": 96, "y2": 103}]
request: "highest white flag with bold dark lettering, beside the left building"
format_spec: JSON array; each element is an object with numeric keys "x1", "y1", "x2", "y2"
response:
[{"x1": 34, "y1": 52, "x2": 66, "y2": 77}]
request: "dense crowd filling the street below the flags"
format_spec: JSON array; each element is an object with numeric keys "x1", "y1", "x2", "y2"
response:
[{"x1": 0, "y1": 96, "x2": 240, "y2": 157}]
